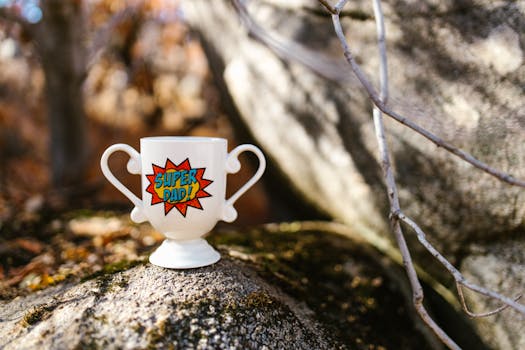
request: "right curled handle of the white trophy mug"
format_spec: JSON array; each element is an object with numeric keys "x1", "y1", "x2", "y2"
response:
[{"x1": 222, "y1": 145, "x2": 266, "y2": 222}]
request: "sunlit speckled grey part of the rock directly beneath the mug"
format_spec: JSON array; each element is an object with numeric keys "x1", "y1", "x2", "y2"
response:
[{"x1": 0, "y1": 260, "x2": 332, "y2": 349}]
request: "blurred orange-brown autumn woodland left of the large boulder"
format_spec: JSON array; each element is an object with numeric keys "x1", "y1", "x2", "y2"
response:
[{"x1": 0, "y1": 0, "x2": 272, "y2": 297}]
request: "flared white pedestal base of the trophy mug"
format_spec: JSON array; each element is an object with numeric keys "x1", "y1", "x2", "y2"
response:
[{"x1": 149, "y1": 238, "x2": 221, "y2": 269}]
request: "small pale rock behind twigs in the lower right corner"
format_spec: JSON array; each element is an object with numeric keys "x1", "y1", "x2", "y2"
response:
[{"x1": 461, "y1": 240, "x2": 525, "y2": 349}]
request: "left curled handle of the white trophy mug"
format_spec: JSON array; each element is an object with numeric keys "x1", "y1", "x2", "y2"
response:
[{"x1": 100, "y1": 143, "x2": 147, "y2": 223}]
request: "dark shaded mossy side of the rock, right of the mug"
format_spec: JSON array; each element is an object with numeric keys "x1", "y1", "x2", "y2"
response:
[{"x1": 209, "y1": 225, "x2": 428, "y2": 349}]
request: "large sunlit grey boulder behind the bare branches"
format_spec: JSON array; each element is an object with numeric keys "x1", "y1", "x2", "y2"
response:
[{"x1": 183, "y1": 0, "x2": 525, "y2": 348}]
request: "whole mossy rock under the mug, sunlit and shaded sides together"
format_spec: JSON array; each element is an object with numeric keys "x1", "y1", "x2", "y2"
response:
[{"x1": 0, "y1": 226, "x2": 429, "y2": 349}]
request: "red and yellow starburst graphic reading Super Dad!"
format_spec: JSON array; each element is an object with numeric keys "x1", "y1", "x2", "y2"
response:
[{"x1": 146, "y1": 158, "x2": 213, "y2": 217}]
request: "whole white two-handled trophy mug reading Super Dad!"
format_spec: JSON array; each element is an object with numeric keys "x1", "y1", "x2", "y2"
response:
[{"x1": 100, "y1": 136, "x2": 266, "y2": 268}]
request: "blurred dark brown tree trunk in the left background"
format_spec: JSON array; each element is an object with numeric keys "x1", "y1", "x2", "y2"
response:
[{"x1": 34, "y1": 0, "x2": 87, "y2": 188}]
